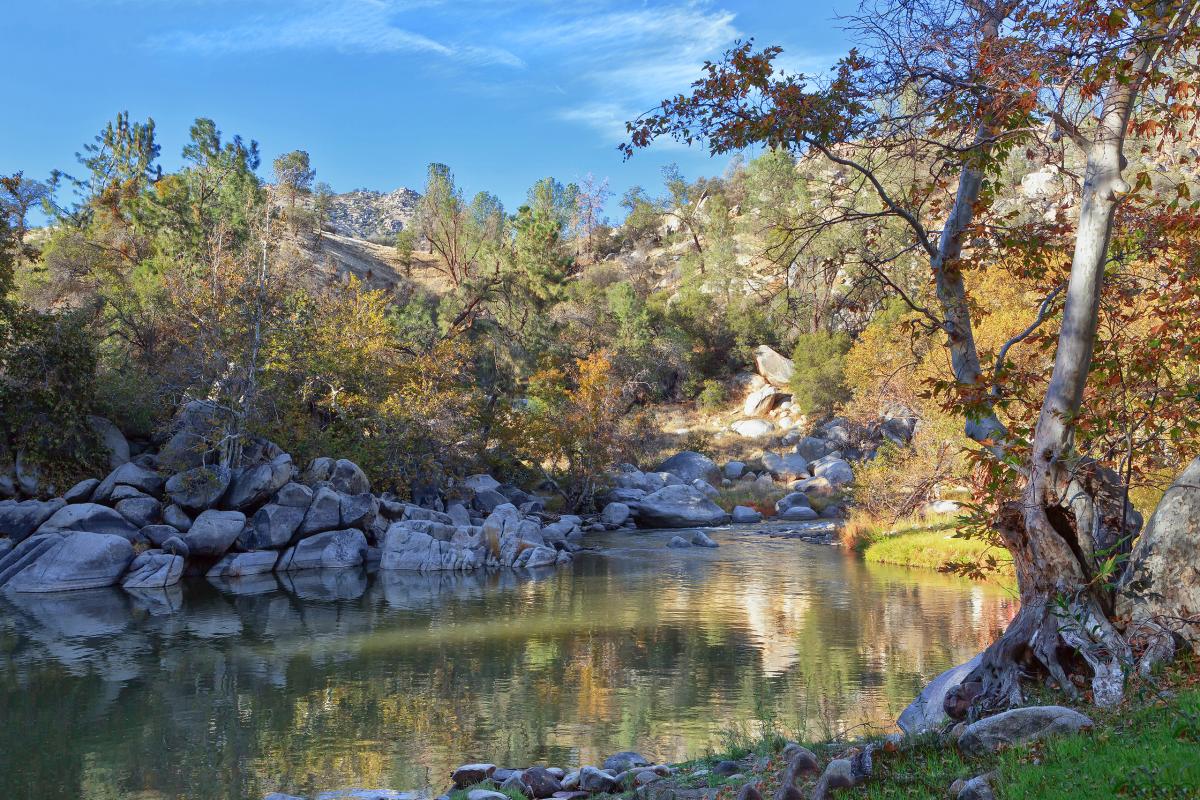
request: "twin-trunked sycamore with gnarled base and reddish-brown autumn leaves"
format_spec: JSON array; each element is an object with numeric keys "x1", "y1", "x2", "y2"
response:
[{"x1": 623, "y1": 0, "x2": 1200, "y2": 716}]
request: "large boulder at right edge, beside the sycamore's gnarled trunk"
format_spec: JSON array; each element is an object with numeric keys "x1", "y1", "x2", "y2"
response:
[{"x1": 1117, "y1": 457, "x2": 1200, "y2": 650}]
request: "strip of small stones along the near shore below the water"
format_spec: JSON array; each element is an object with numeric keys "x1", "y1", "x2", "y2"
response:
[{"x1": 255, "y1": 700, "x2": 1132, "y2": 800}]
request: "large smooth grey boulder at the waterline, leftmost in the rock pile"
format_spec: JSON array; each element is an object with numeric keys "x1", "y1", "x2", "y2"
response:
[{"x1": 7, "y1": 531, "x2": 133, "y2": 593}]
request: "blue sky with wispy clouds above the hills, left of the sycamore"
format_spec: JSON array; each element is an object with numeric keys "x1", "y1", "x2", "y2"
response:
[{"x1": 7, "y1": 0, "x2": 852, "y2": 216}]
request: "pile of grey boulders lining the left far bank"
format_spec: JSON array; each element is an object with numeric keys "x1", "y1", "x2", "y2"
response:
[{"x1": 0, "y1": 450, "x2": 580, "y2": 593}]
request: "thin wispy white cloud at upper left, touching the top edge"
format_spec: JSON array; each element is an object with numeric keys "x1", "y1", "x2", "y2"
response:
[{"x1": 151, "y1": 0, "x2": 523, "y2": 67}]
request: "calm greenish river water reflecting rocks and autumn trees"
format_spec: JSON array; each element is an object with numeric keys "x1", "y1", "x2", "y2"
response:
[{"x1": 0, "y1": 528, "x2": 1016, "y2": 800}]
